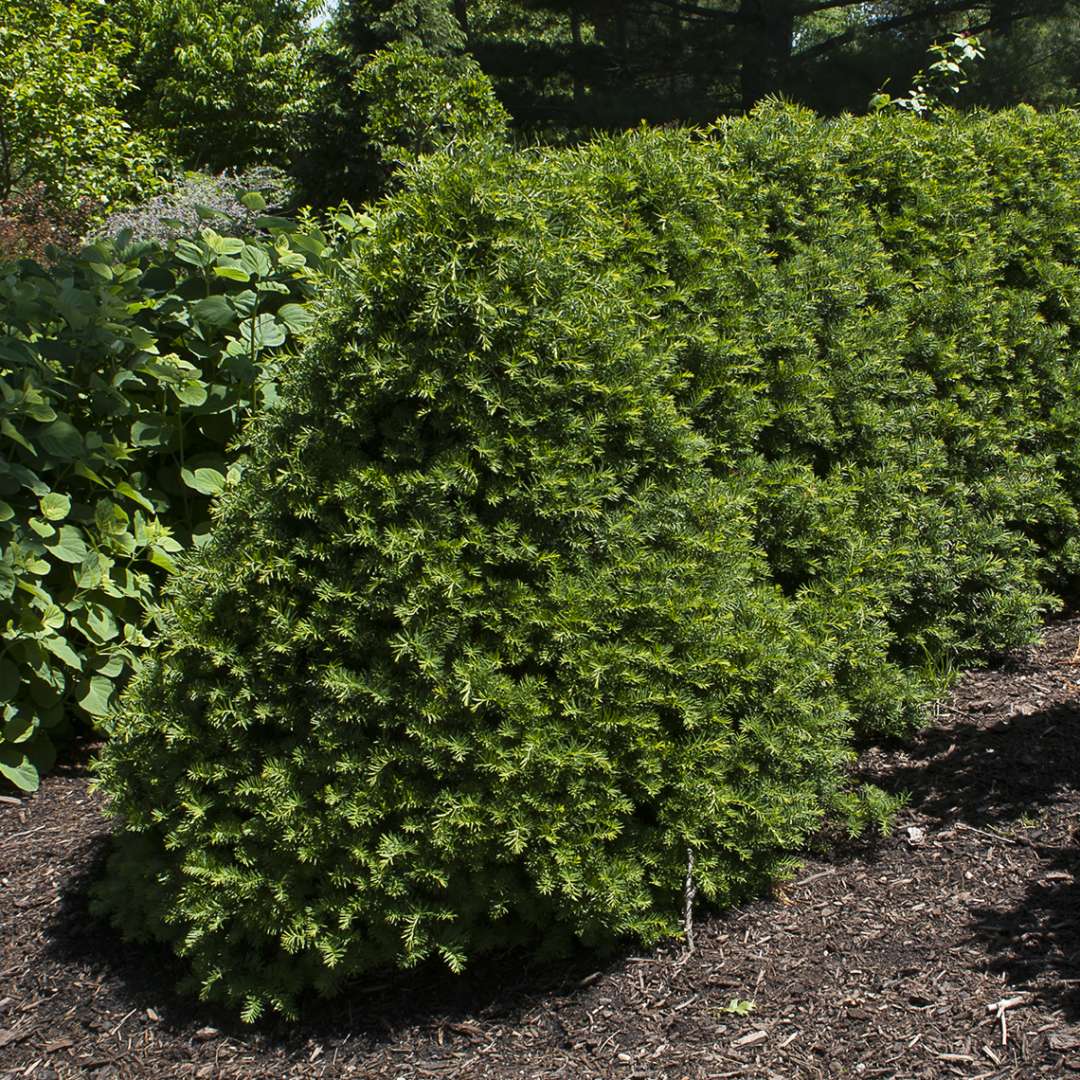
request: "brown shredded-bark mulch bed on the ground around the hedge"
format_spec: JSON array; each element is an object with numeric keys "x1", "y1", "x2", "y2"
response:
[{"x1": 0, "y1": 619, "x2": 1080, "y2": 1080}]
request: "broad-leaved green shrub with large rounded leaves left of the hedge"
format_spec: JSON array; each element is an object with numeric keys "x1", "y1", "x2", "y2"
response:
[{"x1": 0, "y1": 206, "x2": 371, "y2": 789}]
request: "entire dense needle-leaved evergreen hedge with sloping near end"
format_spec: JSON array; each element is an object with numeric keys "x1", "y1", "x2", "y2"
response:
[{"x1": 97, "y1": 107, "x2": 1080, "y2": 1018}]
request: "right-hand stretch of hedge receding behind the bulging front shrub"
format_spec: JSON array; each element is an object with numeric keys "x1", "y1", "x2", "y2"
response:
[{"x1": 691, "y1": 110, "x2": 1080, "y2": 733}]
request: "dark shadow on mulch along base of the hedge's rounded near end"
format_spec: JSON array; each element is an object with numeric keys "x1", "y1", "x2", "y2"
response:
[{"x1": 46, "y1": 836, "x2": 633, "y2": 1053}]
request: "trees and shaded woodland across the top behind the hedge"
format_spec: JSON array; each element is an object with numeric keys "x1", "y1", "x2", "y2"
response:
[{"x1": 8, "y1": 0, "x2": 1080, "y2": 227}]
